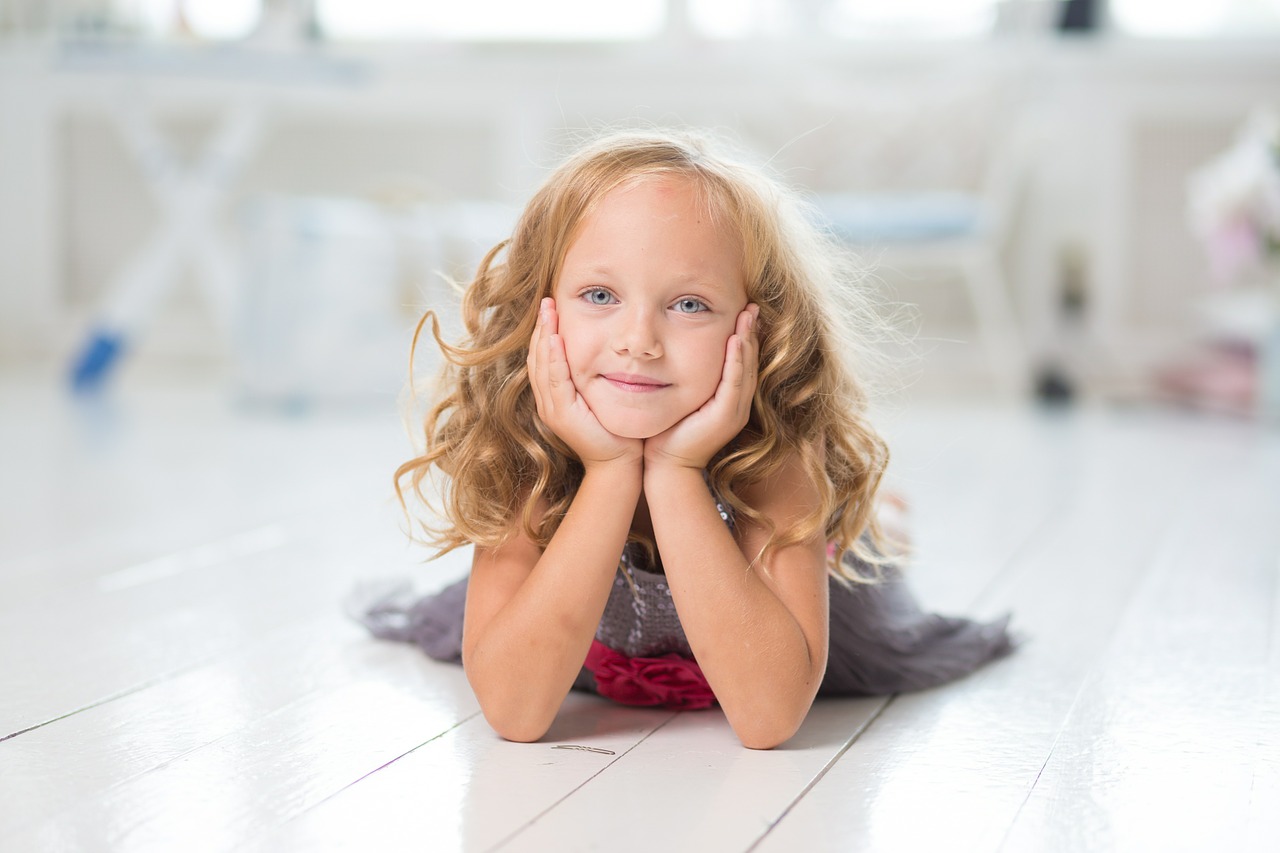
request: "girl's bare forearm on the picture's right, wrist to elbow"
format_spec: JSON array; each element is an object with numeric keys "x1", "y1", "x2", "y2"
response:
[{"x1": 644, "y1": 467, "x2": 826, "y2": 747}]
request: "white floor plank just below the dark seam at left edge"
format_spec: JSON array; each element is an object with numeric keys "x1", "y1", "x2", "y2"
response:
[{"x1": 0, "y1": 613, "x2": 479, "y2": 838}]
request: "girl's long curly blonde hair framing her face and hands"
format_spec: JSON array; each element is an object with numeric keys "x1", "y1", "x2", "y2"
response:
[{"x1": 394, "y1": 132, "x2": 888, "y2": 581}]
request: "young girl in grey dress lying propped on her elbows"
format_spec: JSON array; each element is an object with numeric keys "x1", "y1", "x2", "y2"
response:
[{"x1": 364, "y1": 126, "x2": 1010, "y2": 748}]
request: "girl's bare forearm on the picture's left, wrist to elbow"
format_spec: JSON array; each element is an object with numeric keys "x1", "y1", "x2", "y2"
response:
[{"x1": 463, "y1": 465, "x2": 641, "y2": 740}]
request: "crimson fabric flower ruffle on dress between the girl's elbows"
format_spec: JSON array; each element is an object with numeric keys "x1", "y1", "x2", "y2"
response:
[{"x1": 585, "y1": 640, "x2": 716, "y2": 711}]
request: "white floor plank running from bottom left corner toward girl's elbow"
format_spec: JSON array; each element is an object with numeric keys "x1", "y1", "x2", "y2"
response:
[{"x1": 6, "y1": 648, "x2": 476, "y2": 850}]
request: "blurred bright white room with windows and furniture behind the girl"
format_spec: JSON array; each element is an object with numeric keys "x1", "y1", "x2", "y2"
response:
[{"x1": 0, "y1": 0, "x2": 1280, "y2": 416}]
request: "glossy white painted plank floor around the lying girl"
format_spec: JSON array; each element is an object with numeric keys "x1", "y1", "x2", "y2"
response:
[{"x1": 0, "y1": 366, "x2": 1280, "y2": 853}]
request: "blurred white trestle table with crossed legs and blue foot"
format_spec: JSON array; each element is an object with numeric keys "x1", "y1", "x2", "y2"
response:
[{"x1": 58, "y1": 42, "x2": 364, "y2": 391}]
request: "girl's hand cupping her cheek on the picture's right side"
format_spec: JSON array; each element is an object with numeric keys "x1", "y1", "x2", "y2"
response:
[{"x1": 644, "y1": 304, "x2": 760, "y2": 470}]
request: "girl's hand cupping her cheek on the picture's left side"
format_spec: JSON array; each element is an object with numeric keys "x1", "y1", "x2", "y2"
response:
[{"x1": 526, "y1": 298, "x2": 644, "y2": 467}]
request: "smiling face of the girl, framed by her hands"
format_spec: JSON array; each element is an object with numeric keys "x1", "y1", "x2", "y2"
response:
[{"x1": 553, "y1": 178, "x2": 746, "y2": 438}]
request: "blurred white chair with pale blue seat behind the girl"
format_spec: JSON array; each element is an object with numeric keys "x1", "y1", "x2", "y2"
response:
[{"x1": 747, "y1": 81, "x2": 1037, "y2": 391}]
